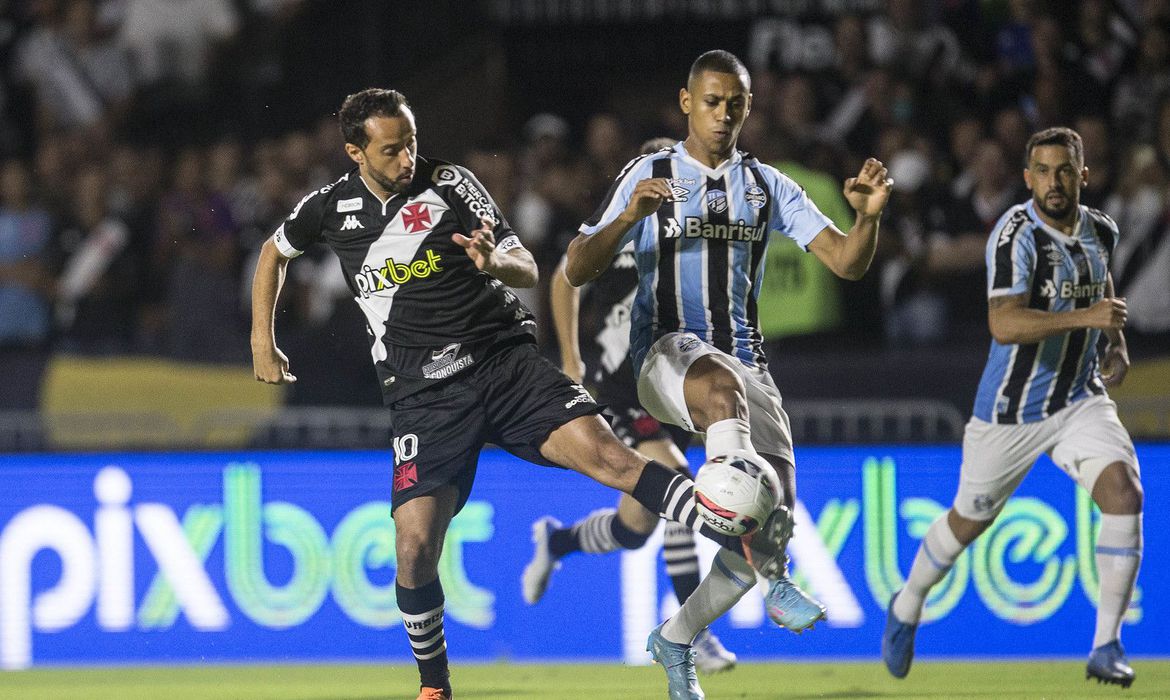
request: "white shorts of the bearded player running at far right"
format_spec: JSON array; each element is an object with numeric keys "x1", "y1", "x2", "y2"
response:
[{"x1": 954, "y1": 396, "x2": 1141, "y2": 520}]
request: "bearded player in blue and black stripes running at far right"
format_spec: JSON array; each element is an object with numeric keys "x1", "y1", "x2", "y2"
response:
[{"x1": 882, "y1": 128, "x2": 1142, "y2": 687}]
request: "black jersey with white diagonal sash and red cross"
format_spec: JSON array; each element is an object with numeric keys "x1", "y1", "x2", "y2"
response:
[{"x1": 273, "y1": 157, "x2": 536, "y2": 405}]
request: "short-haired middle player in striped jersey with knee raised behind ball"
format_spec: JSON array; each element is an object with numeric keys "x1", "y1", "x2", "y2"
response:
[{"x1": 565, "y1": 50, "x2": 890, "y2": 699}]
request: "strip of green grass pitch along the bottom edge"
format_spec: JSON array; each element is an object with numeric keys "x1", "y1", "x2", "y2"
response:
[{"x1": 0, "y1": 659, "x2": 1170, "y2": 700}]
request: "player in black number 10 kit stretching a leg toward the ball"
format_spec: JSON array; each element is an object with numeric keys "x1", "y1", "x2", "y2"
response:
[{"x1": 252, "y1": 89, "x2": 789, "y2": 700}]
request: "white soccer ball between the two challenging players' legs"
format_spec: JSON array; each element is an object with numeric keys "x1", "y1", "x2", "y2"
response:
[{"x1": 695, "y1": 454, "x2": 780, "y2": 535}]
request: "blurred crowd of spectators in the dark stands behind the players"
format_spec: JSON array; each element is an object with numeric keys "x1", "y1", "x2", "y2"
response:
[{"x1": 0, "y1": 0, "x2": 1170, "y2": 407}]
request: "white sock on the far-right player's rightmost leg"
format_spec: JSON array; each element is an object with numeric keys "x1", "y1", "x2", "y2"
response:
[{"x1": 1093, "y1": 513, "x2": 1142, "y2": 648}]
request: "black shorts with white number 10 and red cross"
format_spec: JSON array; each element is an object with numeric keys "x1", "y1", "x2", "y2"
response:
[{"x1": 390, "y1": 343, "x2": 601, "y2": 513}]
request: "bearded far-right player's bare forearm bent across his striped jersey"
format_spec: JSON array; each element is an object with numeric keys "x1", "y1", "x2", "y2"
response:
[{"x1": 987, "y1": 294, "x2": 1128, "y2": 346}]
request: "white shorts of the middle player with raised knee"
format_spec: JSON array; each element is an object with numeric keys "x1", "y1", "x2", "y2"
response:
[{"x1": 638, "y1": 332, "x2": 796, "y2": 465}]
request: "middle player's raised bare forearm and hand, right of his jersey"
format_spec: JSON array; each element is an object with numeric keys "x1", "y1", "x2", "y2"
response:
[{"x1": 808, "y1": 158, "x2": 894, "y2": 280}]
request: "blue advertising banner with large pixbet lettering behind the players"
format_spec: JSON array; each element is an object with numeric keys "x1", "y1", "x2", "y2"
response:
[{"x1": 0, "y1": 445, "x2": 1170, "y2": 668}]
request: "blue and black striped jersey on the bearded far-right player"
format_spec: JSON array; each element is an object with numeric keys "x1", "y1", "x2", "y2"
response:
[{"x1": 975, "y1": 201, "x2": 1117, "y2": 424}]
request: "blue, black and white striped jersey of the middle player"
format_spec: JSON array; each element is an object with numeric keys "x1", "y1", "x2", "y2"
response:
[{"x1": 580, "y1": 142, "x2": 831, "y2": 373}]
